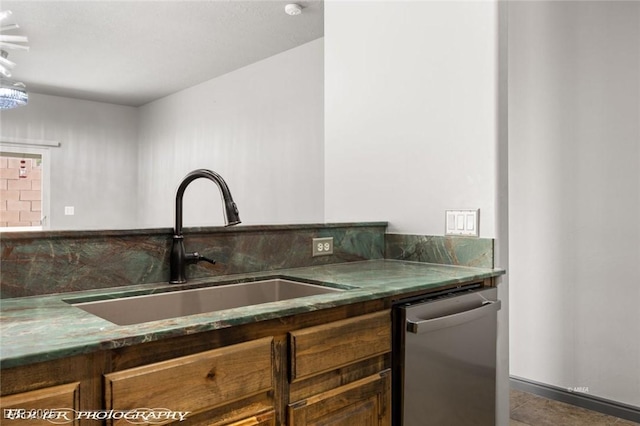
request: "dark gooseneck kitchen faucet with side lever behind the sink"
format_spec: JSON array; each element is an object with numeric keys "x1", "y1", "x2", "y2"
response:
[{"x1": 169, "y1": 169, "x2": 240, "y2": 284}]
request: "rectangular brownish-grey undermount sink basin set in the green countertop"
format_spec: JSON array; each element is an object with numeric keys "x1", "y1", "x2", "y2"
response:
[{"x1": 67, "y1": 278, "x2": 342, "y2": 325}]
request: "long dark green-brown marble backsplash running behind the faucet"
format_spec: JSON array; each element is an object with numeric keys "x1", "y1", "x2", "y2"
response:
[{"x1": 0, "y1": 222, "x2": 387, "y2": 298}]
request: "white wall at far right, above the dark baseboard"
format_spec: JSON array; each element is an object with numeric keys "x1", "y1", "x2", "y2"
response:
[{"x1": 509, "y1": 1, "x2": 640, "y2": 406}]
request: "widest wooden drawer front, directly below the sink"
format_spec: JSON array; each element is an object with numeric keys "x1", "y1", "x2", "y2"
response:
[{"x1": 105, "y1": 337, "x2": 273, "y2": 422}]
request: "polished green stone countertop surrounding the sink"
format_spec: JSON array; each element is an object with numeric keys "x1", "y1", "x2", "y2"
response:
[{"x1": 0, "y1": 260, "x2": 504, "y2": 368}]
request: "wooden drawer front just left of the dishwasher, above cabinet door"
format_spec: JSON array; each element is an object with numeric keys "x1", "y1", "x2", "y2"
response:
[{"x1": 289, "y1": 310, "x2": 391, "y2": 382}]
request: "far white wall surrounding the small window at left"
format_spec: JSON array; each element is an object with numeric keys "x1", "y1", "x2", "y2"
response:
[{"x1": 1, "y1": 93, "x2": 138, "y2": 229}]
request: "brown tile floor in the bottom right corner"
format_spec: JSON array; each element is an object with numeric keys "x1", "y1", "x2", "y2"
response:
[{"x1": 510, "y1": 389, "x2": 640, "y2": 426}]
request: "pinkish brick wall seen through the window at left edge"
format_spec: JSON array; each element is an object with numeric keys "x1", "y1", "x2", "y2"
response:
[{"x1": 0, "y1": 156, "x2": 42, "y2": 227}]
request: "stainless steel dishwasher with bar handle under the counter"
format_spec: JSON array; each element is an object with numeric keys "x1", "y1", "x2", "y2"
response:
[{"x1": 393, "y1": 284, "x2": 500, "y2": 426}]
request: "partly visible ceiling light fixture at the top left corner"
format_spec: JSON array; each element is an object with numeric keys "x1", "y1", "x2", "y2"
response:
[{"x1": 0, "y1": 10, "x2": 29, "y2": 109}]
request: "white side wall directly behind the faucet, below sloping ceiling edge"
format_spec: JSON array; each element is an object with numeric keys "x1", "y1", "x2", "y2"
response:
[{"x1": 139, "y1": 39, "x2": 324, "y2": 227}]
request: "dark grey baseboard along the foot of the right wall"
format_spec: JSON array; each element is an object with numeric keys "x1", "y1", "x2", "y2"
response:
[{"x1": 510, "y1": 376, "x2": 640, "y2": 423}]
